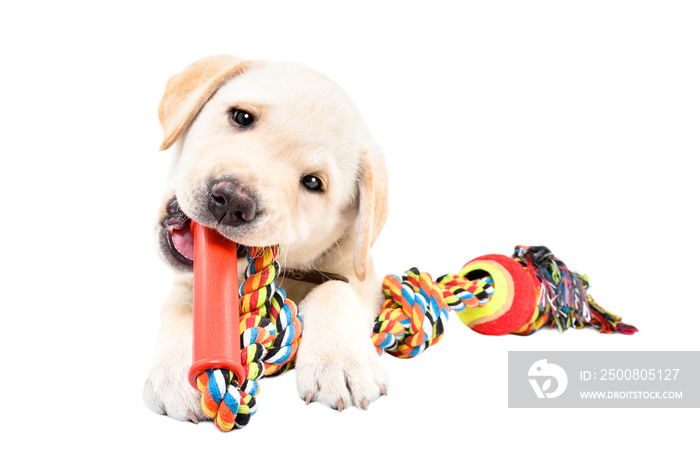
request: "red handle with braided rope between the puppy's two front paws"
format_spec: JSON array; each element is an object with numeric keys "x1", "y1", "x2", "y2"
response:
[{"x1": 189, "y1": 221, "x2": 302, "y2": 431}]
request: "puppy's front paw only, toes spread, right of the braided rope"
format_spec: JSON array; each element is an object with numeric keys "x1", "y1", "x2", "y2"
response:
[{"x1": 296, "y1": 339, "x2": 388, "y2": 411}]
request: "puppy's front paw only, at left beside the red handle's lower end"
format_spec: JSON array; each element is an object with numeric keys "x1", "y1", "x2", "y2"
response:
[{"x1": 143, "y1": 350, "x2": 207, "y2": 424}]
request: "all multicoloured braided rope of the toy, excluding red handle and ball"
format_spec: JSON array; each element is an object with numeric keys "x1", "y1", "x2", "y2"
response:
[{"x1": 197, "y1": 246, "x2": 637, "y2": 431}]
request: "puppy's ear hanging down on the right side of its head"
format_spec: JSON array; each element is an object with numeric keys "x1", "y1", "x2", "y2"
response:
[{"x1": 353, "y1": 148, "x2": 389, "y2": 281}]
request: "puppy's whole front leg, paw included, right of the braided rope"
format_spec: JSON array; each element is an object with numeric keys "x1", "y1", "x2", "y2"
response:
[{"x1": 296, "y1": 281, "x2": 388, "y2": 411}]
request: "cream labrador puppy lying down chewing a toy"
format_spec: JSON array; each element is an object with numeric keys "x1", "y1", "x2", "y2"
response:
[{"x1": 144, "y1": 55, "x2": 387, "y2": 422}]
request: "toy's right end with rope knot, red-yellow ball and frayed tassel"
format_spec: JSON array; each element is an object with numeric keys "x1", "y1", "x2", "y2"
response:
[{"x1": 372, "y1": 246, "x2": 637, "y2": 358}]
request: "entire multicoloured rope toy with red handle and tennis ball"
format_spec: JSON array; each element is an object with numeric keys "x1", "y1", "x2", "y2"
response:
[{"x1": 189, "y1": 221, "x2": 637, "y2": 431}]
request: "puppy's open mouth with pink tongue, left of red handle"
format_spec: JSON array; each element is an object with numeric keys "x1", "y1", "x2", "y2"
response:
[{"x1": 161, "y1": 198, "x2": 247, "y2": 270}]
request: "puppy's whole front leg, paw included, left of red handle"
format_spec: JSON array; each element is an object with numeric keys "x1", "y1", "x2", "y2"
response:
[{"x1": 143, "y1": 276, "x2": 207, "y2": 423}]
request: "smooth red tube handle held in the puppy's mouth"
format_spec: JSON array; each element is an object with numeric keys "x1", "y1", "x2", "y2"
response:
[{"x1": 188, "y1": 221, "x2": 245, "y2": 388}]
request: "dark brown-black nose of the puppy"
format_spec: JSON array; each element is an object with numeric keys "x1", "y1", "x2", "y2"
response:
[{"x1": 209, "y1": 180, "x2": 258, "y2": 227}]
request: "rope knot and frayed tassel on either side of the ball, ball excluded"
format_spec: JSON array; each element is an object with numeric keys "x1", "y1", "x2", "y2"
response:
[{"x1": 372, "y1": 246, "x2": 637, "y2": 348}]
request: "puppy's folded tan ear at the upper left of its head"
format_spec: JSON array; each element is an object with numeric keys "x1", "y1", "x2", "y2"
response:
[{"x1": 158, "y1": 55, "x2": 248, "y2": 150}]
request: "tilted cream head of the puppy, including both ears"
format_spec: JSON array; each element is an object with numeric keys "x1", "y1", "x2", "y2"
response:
[{"x1": 157, "y1": 55, "x2": 387, "y2": 280}]
